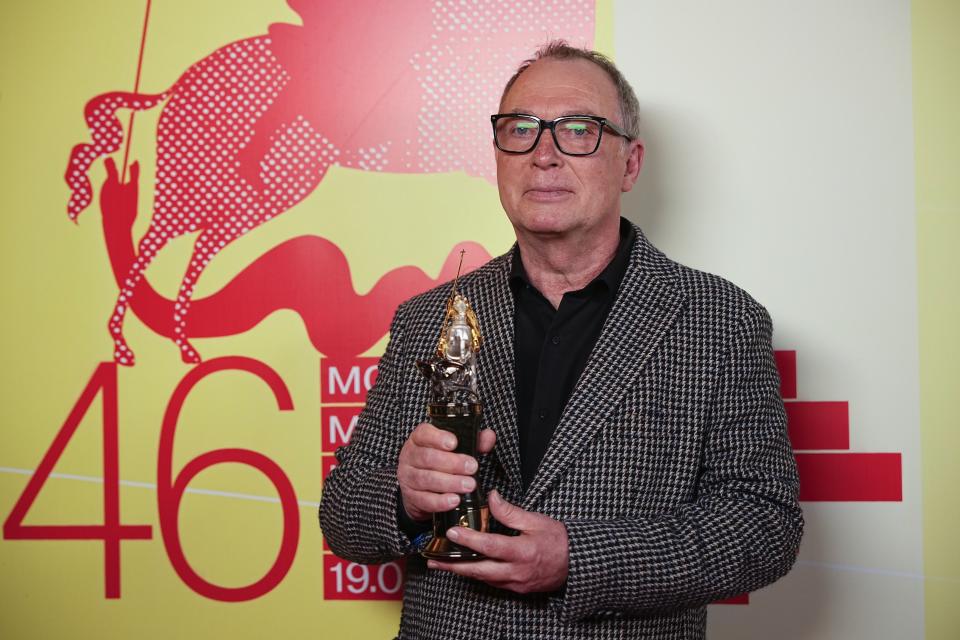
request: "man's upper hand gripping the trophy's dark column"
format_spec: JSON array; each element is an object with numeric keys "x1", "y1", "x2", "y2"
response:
[{"x1": 397, "y1": 422, "x2": 497, "y2": 521}]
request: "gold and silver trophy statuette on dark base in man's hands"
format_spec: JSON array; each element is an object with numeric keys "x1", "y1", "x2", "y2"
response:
[{"x1": 417, "y1": 254, "x2": 490, "y2": 561}]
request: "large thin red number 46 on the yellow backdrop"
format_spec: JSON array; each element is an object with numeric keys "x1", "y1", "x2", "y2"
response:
[{"x1": 3, "y1": 357, "x2": 300, "y2": 601}]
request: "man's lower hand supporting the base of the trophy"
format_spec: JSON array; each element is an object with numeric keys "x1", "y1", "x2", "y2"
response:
[{"x1": 427, "y1": 491, "x2": 570, "y2": 593}]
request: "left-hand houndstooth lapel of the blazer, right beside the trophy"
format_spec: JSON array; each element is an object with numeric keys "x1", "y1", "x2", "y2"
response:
[{"x1": 470, "y1": 251, "x2": 523, "y2": 497}]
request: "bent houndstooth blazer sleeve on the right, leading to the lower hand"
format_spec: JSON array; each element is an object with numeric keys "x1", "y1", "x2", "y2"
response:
[{"x1": 552, "y1": 301, "x2": 803, "y2": 620}]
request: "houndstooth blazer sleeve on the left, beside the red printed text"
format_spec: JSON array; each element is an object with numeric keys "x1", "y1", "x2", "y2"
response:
[{"x1": 320, "y1": 305, "x2": 415, "y2": 564}]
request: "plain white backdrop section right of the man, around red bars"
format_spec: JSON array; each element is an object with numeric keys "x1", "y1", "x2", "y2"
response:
[{"x1": 615, "y1": 0, "x2": 923, "y2": 640}]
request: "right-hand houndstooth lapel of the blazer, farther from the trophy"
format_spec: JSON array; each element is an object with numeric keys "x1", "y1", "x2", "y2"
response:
[{"x1": 511, "y1": 229, "x2": 685, "y2": 510}]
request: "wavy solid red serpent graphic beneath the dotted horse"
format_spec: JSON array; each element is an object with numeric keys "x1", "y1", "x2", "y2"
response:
[{"x1": 100, "y1": 158, "x2": 490, "y2": 357}]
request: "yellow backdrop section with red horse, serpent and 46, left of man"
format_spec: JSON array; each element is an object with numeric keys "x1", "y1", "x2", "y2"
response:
[{"x1": 0, "y1": 0, "x2": 592, "y2": 638}]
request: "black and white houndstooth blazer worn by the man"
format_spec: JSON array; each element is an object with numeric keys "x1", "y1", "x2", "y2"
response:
[{"x1": 320, "y1": 222, "x2": 803, "y2": 640}]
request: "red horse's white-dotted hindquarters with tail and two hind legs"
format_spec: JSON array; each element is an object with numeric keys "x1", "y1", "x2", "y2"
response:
[{"x1": 67, "y1": 38, "x2": 330, "y2": 365}]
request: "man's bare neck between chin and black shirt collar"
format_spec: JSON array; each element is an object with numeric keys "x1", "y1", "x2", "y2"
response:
[{"x1": 517, "y1": 218, "x2": 620, "y2": 309}]
